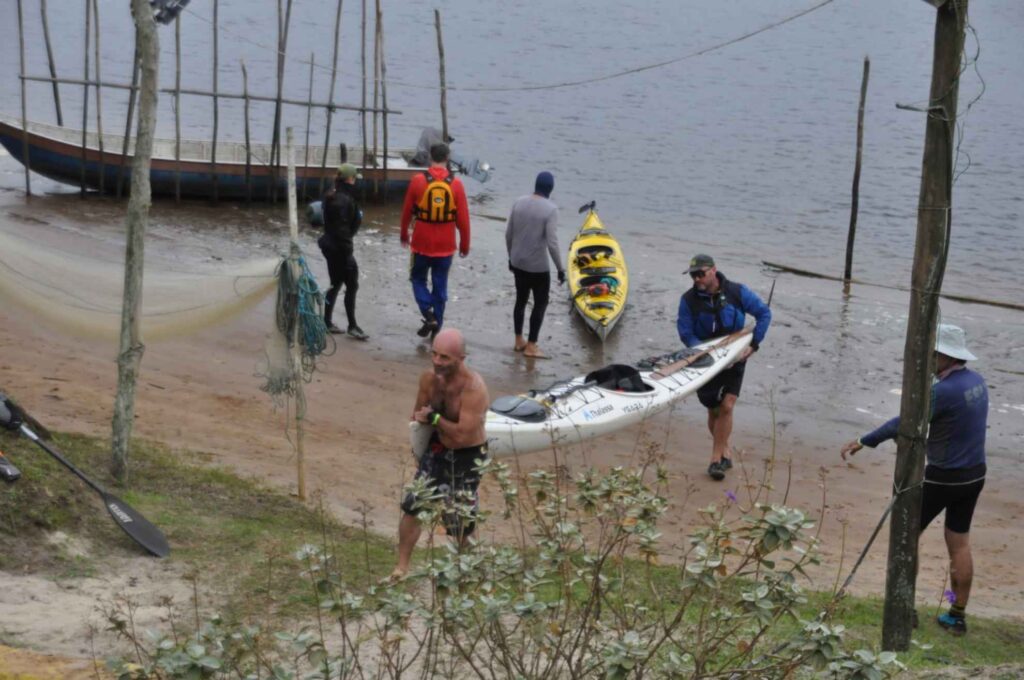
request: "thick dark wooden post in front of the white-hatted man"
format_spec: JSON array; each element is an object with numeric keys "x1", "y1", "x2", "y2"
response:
[{"x1": 882, "y1": 0, "x2": 968, "y2": 651}]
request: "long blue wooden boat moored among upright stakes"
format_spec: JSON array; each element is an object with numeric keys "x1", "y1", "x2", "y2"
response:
[{"x1": 0, "y1": 117, "x2": 423, "y2": 201}]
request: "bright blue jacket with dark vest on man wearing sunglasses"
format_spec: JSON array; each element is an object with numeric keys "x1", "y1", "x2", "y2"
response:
[{"x1": 676, "y1": 271, "x2": 771, "y2": 349}]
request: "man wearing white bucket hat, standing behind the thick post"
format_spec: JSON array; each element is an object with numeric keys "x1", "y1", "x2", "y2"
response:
[{"x1": 841, "y1": 324, "x2": 988, "y2": 635}]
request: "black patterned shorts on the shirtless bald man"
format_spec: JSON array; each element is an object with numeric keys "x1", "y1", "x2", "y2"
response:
[{"x1": 401, "y1": 435, "x2": 487, "y2": 538}]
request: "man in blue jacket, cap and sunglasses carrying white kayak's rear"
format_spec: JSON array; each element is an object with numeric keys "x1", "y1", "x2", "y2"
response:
[{"x1": 676, "y1": 254, "x2": 771, "y2": 481}]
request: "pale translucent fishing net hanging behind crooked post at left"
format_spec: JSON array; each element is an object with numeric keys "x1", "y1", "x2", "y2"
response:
[{"x1": 0, "y1": 227, "x2": 281, "y2": 340}]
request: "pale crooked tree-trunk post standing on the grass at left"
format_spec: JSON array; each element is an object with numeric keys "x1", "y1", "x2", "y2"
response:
[{"x1": 111, "y1": 0, "x2": 160, "y2": 480}]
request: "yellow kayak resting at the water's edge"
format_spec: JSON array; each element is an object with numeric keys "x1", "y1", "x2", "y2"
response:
[{"x1": 565, "y1": 202, "x2": 630, "y2": 342}]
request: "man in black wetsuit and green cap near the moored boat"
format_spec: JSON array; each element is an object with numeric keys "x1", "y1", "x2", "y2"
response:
[{"x1": 316, "y1": 163, "x2": 370, "y2": 340}]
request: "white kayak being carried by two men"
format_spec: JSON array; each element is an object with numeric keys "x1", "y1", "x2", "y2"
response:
[{"x1": 410, "y1": 327, "x2": 753, "y2": 458}]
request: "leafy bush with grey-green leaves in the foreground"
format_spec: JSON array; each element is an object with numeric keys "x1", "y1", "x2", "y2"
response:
[{"x1": 109, "y1": 461, "x2": 902, "y2": 680}]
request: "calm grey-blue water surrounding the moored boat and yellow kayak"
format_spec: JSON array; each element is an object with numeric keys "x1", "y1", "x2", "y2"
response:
[{"x1": 0, "y1": 0, "x2": 1024, "y2": 460}]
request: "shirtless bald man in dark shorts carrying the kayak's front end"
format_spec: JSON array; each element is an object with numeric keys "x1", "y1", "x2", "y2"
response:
[{"x1": 392, "y1": 329, "x2": 490, "y2": 577}]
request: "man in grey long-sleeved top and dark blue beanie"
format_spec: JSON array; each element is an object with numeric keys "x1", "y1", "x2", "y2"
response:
[{"x1": 505, "y1": 172, "x2": 565, "y2": 358}]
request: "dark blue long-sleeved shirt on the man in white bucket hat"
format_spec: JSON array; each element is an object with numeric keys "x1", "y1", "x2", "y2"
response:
[{"x1": 860, "y1": 369, "x2": 988, "y2": 470}]
